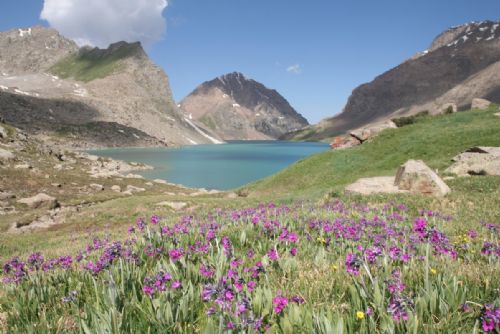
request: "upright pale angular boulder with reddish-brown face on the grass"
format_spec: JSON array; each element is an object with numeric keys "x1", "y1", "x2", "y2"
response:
[{"x1": 394, "y1": 160, "x2": 450, "y2": 197}]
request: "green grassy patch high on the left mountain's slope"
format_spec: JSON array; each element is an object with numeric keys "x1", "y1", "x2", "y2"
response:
[{"x1": 51, "y1": 44, "x2": 137, "y2": 82}]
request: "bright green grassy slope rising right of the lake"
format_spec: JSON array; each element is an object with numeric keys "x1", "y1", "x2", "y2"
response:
[{"x1": 242, "y1": 106, "x2": 500, "y2": 197}]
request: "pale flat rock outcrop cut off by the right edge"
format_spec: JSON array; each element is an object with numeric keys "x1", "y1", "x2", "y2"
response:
[{"x1": 446, "y1": 147, "x2": 500, "y2": 176}]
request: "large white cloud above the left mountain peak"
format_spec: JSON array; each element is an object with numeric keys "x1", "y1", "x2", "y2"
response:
[{"x1": 40, "y1": 0, "x2": 168, "y2": 48}]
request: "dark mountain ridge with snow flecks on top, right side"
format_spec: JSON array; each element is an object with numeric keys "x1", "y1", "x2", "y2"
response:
[{"x1": 285, "y1": 21, "x2": 500, "y2": 140}]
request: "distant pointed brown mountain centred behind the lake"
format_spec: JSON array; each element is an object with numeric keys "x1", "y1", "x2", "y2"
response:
[{"x1": 180, "y1": 72, "x2": 308, "y2": 140}]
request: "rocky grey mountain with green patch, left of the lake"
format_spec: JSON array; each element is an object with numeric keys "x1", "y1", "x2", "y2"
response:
[{"x1": 0, "y1": 26, "x2": 220, "y2": 147}]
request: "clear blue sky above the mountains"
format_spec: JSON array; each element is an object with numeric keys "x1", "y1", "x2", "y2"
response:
[{"x1": 0, "y1": 0, "x2": 500, "y2": 123}]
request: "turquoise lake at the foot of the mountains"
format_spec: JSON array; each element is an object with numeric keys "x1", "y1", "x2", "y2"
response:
[{"x1": 88, "y1": 141, "x2": 329, "y2": 190}]
